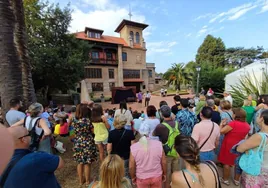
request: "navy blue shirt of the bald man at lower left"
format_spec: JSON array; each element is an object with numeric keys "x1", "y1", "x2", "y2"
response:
[{"x1": 4, "y1": 149, "x2": 61, "y2": 188}]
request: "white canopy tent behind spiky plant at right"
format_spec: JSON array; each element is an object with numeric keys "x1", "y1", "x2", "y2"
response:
[{"x1": 225, "y1": 59, "x2": 268, "y2": 91}]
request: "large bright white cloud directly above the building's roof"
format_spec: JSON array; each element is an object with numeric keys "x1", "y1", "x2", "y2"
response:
[{"x1": 69, "y1": 3, "x2": 147, "y2": 36}]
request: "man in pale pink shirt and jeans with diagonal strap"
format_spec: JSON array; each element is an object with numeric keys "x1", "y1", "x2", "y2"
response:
[{"x1": 192, "y1": 107, "x2": 220, "y2": 161}]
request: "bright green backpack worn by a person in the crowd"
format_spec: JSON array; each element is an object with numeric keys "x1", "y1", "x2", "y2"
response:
[{"x1": 162, "y1": 121, "x2": 180, "y2": 157}]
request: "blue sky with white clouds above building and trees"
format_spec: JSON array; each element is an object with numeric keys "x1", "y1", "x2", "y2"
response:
[{"x1": 50, "y1": 0, "x2": 268, "y2": 73}]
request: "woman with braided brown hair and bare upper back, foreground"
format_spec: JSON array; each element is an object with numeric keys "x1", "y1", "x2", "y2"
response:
[{"x1": 171, "y1": 135, "x2": 221, "y2": 188}]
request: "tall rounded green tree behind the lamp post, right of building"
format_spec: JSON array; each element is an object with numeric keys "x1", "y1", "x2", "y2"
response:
[{"x1": 196, "y1": 35, "x2": 226, "y2": 66}]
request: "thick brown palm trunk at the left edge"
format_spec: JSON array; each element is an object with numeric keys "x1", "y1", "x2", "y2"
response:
[{"x1": 0, "y1": 0, "x2": 36, "y2": 112}]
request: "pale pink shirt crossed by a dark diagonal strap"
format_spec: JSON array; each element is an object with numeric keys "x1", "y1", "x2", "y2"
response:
[{"x1": 192, "y1": 120, "x2": 220, "y2": 152}]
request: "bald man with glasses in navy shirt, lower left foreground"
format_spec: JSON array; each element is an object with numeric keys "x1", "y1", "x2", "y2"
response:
[{"x1": 0, "y1": 126, "x2": 64, "y2": 188}]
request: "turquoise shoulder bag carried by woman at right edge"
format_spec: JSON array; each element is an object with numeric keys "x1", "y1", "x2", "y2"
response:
[{"x1": 239, "y1": 133, "x2": 267, "y2": 176}]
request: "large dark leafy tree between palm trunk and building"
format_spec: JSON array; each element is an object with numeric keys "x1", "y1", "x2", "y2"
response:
[{"x1": 24, "y1": 0, "x2": 90, "y2": 98}]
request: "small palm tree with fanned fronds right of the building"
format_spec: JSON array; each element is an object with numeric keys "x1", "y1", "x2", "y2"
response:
[{"x1": 163, "y1": 63, "x2": 193, "y2": 90}]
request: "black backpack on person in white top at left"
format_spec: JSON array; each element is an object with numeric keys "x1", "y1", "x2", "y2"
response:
[{"x1": 23, "y1": 117, "x2": 44, "y2": 151}]
